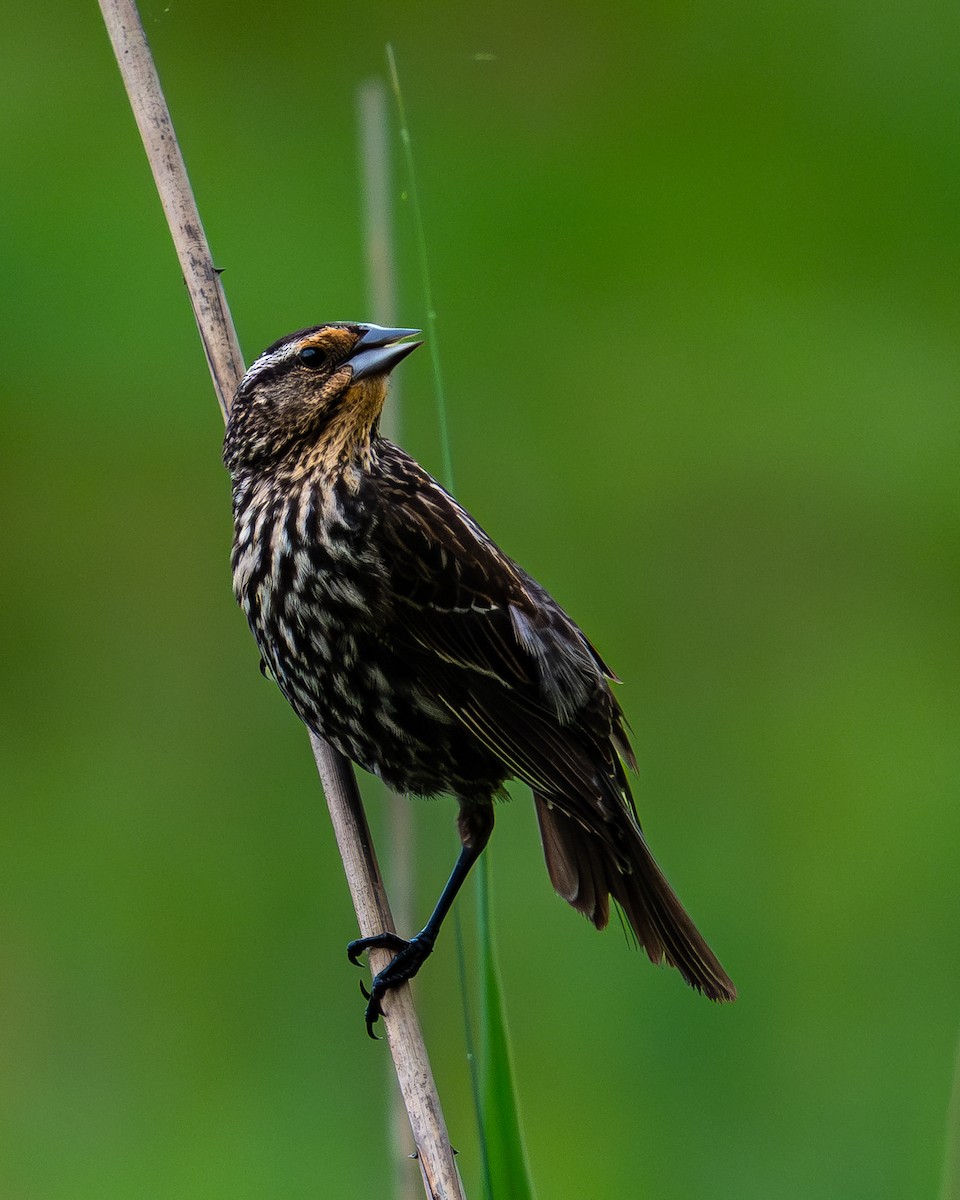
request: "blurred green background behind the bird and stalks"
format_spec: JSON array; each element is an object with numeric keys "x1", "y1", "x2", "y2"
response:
[{"x1": 0, "y1": 0, "x2": 960, "y2": 1200}]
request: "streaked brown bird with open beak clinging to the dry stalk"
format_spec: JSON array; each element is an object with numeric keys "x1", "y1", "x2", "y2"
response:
[{"x1": 223, "y1": 323, "x2": 736, "y2": 1036}]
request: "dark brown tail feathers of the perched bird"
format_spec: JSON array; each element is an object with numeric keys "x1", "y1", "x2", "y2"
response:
[{"x1": 534, "y1": 792, "x2": 737, "y2": 1001}]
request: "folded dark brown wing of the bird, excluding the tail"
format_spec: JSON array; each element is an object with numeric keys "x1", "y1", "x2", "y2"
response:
[{"x1": 373, "y1": 446, "x2": 632, "y2": 850}]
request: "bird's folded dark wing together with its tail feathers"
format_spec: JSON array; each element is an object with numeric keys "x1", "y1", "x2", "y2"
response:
[{"x1": 364, "y1": 446, "x2": 736, "y2": 1000}]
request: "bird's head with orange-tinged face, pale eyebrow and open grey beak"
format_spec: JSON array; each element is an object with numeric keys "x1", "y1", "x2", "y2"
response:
[{"x1": 223, "y1": 322, "x2": 422, "y2": 472}]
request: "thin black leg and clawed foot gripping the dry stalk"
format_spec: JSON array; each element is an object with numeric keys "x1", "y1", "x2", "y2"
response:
[{"x1": 347, "y1": 800, "x2": 493, "y2": 1039}]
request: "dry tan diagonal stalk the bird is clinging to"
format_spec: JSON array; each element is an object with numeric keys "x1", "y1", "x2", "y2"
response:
[{"x1": 100, "y1": 0, "x2": 463, "y2": 1200}]
